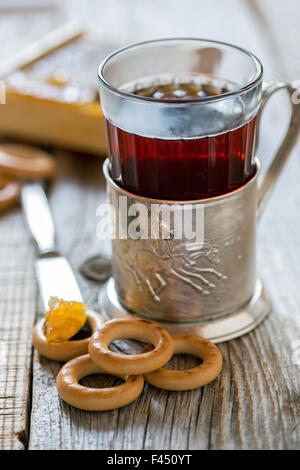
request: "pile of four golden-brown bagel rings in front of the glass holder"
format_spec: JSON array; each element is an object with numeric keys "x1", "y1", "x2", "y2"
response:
[{"x1": 33, "y1": 310, "x2": 222, "y2": 411}]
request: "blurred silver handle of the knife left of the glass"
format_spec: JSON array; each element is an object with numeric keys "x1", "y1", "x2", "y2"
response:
[{"x1": 21, "y1": 183, "x2": 57, "y2": 255}]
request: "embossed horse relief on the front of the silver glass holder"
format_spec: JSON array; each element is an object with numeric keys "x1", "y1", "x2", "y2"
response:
[{"x1": 120, "y1": 234, "x2": 226, "y2": 302}]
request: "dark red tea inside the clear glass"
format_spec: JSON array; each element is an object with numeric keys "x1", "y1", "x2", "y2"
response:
[{"x1": 106, "y1": 84, "x2": 256, "y2": 200}]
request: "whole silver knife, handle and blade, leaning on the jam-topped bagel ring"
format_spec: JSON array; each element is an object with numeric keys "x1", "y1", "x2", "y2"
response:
[{"x1": 21, "y1": 183, "x2": 82, "y2": 311}]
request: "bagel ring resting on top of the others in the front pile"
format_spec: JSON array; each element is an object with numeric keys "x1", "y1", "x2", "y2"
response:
[{"x1": 89, "y1": 318, "x2": 173, "y2": 375}]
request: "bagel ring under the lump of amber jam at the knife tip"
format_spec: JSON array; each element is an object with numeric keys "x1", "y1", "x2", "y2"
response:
[{"x1": 32, "y1": 310, "x2": 104, "y2": 362}]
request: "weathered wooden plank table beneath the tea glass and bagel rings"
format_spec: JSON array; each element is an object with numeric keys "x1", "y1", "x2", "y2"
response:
[{"x1": 0, "y1": 0, "x2": 300, "y2": 449}]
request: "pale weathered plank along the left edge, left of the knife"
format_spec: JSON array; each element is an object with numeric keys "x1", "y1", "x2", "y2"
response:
[{"x1": 0, "y1": 210, "x2": 36, "y2": 449}]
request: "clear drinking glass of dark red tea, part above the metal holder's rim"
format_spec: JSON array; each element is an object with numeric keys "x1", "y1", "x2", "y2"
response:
[{"x1": 99, "y1": 39, "x2": 263, "y2": 201}]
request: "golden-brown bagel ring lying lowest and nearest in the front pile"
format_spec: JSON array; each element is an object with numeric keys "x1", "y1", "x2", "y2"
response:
[{"x1": 56, "y1": 354, "x2": 144, "y2": 411}]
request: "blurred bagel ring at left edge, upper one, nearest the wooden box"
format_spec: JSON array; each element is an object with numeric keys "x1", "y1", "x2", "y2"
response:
[{"x1": 0, "y1": 144, "x2": 56, "y2": 179}]
